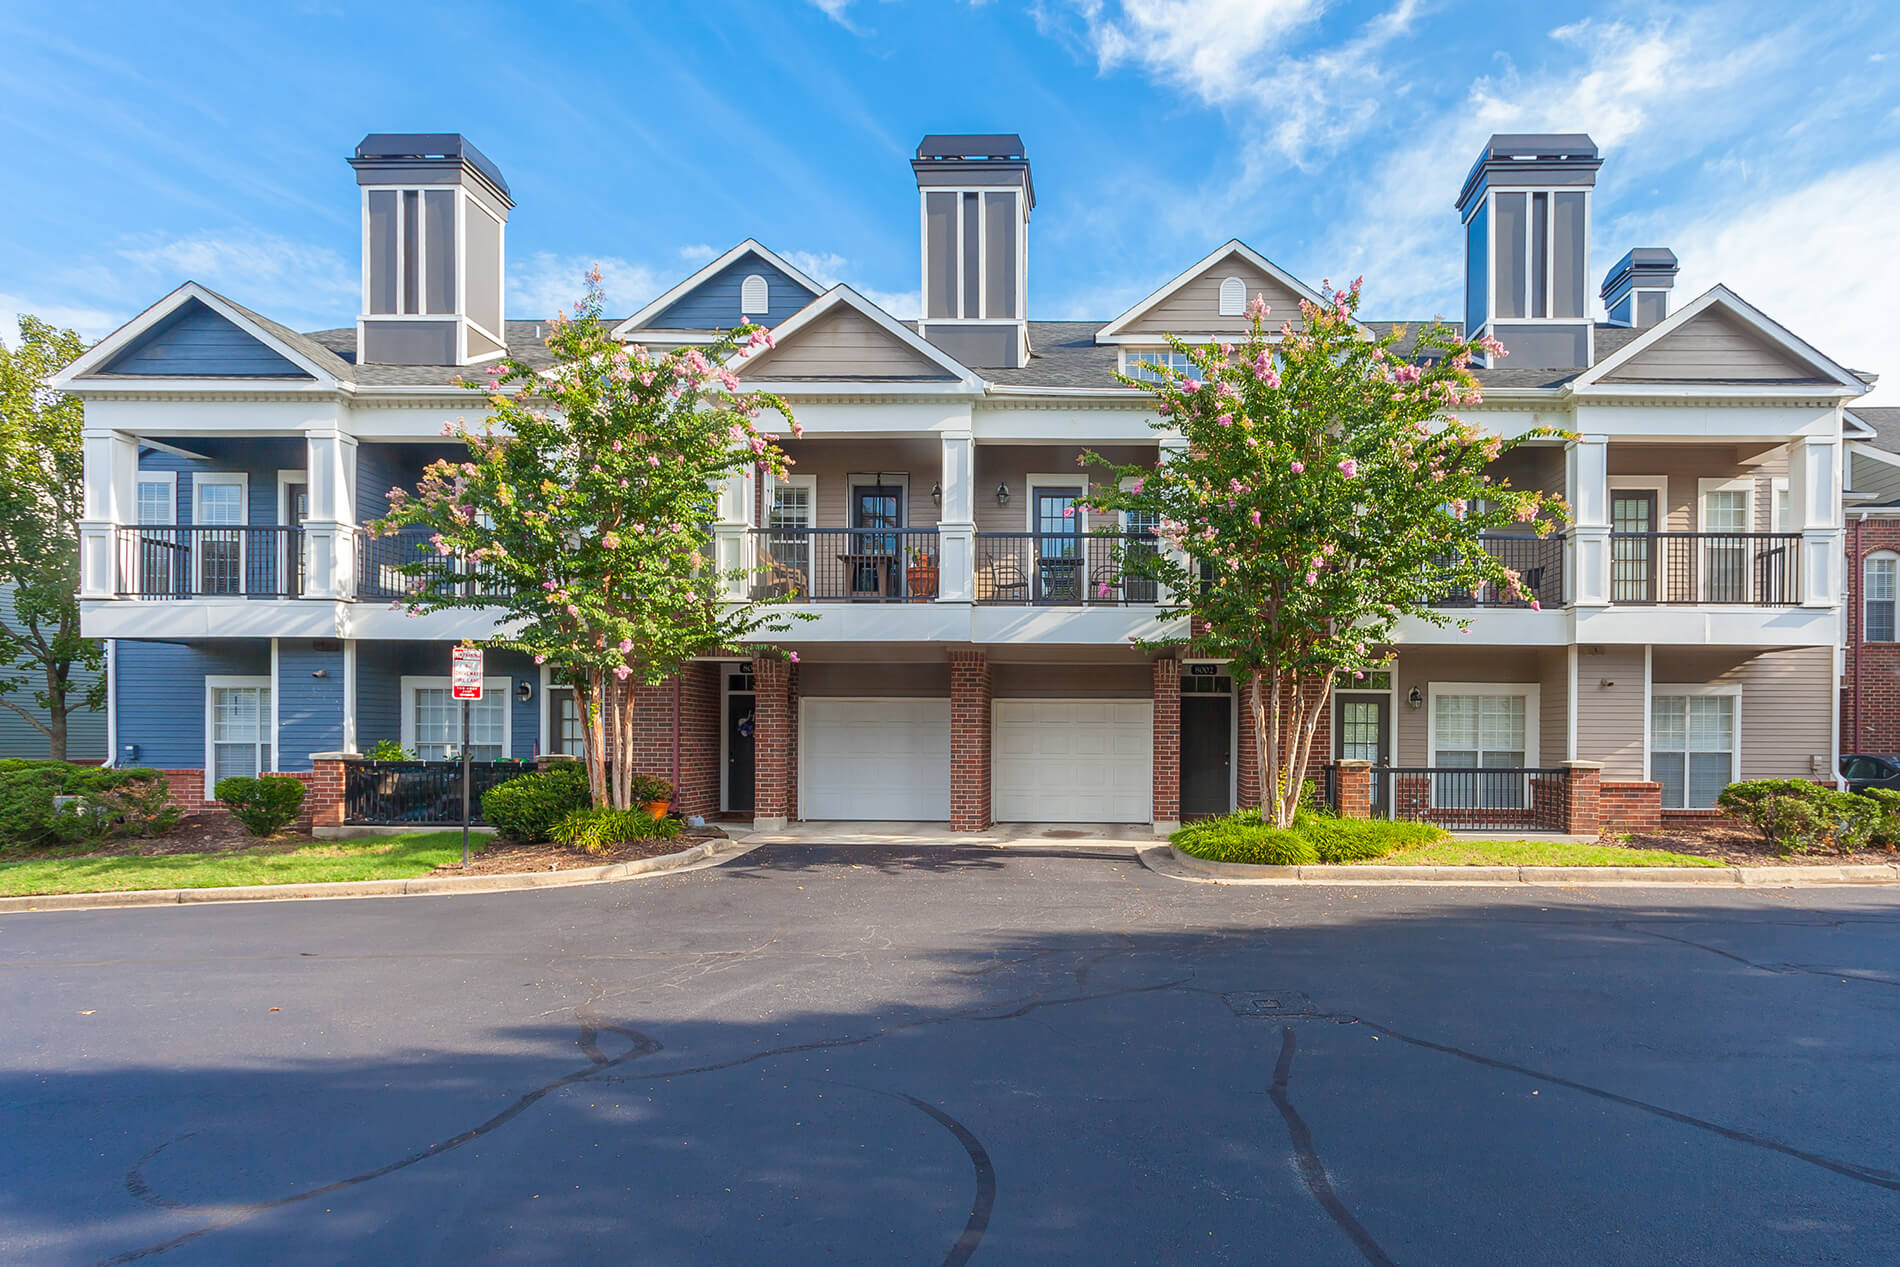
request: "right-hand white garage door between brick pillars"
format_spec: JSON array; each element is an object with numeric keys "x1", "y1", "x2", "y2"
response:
[{"x1": 990, "y1": 699, "x2": 1155, "y2": 823}]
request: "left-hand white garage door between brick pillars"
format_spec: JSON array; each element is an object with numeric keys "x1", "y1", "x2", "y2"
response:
[{"x1": 798, "y1": 697, "x2": 950, "y2": 823}]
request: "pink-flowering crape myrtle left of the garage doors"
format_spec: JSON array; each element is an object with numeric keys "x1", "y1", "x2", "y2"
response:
[{"x1": 369, "y1": 270, "x2": 798, "y2": 809}]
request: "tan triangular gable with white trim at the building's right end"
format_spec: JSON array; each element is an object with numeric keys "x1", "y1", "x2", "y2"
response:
[{"x1": 1573, "y1": 285, "x2": 1868, "y2": 395}]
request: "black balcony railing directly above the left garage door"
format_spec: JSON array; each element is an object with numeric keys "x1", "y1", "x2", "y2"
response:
[{"x1": 751, "y1": 528, "x2": 942, "y2": 602}]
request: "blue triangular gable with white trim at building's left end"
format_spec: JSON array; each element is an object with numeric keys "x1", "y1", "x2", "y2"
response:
[{"x1": 53, "y1": 281, "x2": 350, "y2": 388}]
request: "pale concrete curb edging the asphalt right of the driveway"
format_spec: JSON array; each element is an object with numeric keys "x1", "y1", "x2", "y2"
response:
[{"x1": 1138, "y1": 845, "x2": 1900, "y2": 889}]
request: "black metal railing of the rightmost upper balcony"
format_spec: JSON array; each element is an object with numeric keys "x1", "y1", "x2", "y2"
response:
[{"x1": 1609, "y1": 532, "x2": 1801, "y2": 608}]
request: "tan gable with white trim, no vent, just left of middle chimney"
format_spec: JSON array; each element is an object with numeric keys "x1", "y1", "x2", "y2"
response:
[{"x1": 726, "y1": 283, "x2": 982, "y2": 391}]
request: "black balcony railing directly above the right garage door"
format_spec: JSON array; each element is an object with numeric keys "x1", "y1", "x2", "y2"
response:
[{"x1": 977, "y1": 532, "x2": 1161, "y2": 606}]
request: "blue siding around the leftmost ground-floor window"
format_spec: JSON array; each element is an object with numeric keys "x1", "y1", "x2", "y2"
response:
[{"x1": 114, "y1": 638, "x2": 270, "y2": 769}]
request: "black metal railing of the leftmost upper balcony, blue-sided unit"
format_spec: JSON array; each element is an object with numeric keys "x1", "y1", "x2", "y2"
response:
[{"x1": 114, "y1": 524, "x2": 304, "y2": 598}]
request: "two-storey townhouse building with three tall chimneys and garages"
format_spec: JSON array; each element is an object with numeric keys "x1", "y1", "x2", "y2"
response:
[{"x1": 59, "y1": 135, "x2": 1870, "y2": 828}]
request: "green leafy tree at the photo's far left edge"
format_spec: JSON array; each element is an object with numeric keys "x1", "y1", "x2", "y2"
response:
[{"x1": 0, "y1": 315, "x2": 106, "y2": 762}]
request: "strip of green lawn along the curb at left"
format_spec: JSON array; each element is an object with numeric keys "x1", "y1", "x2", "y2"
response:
[{"x1": 0, "y1": 830, "x2": 483, "y2": 897}]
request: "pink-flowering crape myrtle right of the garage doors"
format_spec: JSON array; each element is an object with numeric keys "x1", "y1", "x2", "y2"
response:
[{"x1": 1089, "y1": 281, "x2": 1566, "y2": 826}]
